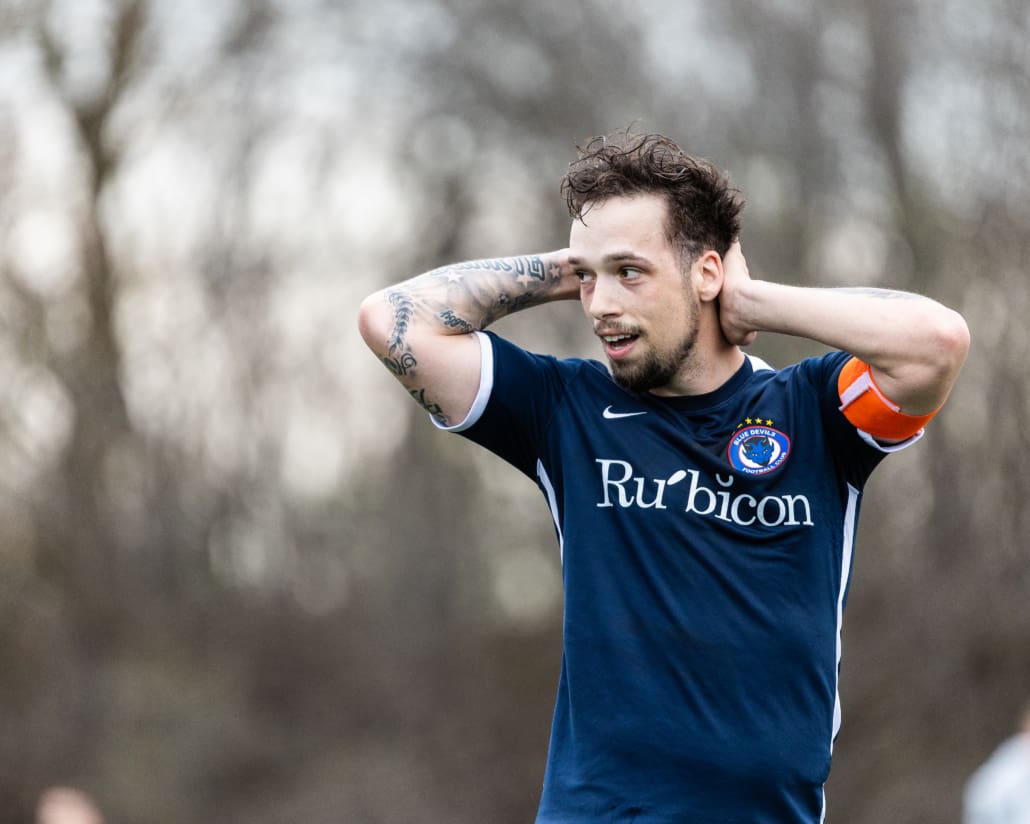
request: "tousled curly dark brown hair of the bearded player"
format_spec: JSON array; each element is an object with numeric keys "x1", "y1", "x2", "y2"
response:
[{"x1": 561, "y1": 129, "x2": 744, "y2": 264}]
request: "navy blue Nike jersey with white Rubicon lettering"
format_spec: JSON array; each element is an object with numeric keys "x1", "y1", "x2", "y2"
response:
[{"x1": 438, "y1": 334, "x2": 922, "y2": 824}]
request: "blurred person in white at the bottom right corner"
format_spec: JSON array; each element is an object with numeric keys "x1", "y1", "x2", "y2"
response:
[{"x1": 962, "y1": 703, "x2": 1030, "y2": 824}]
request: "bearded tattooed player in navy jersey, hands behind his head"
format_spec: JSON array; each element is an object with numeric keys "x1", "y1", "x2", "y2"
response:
[{"x1": 361, "y1": 133, "x2": 968, "y2": 824}]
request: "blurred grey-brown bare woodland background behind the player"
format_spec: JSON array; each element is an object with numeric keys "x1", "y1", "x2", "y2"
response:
[{"x1": 0, "y1": 0, "x2": 1030, "y2": 824}]
